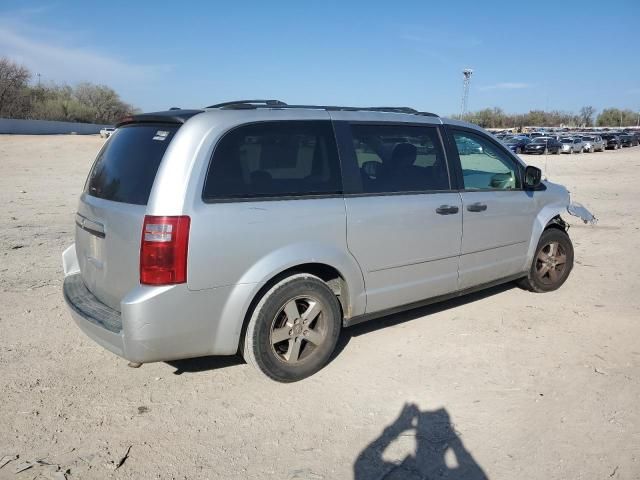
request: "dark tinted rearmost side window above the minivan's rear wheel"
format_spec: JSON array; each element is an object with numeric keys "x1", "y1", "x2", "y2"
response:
[{"x1": 203, "y1": 121, "x2": 342, "y2": 200}]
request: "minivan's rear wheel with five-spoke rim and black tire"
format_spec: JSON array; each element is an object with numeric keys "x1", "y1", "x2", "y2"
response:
[{"x1": 242, "y1": 273, "x2": 342, "y2": 382}]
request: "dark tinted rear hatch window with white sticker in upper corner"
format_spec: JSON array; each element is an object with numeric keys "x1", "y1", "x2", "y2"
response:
[{"x1": 85, "y1": 124, "x2": 179, "y2": 205}]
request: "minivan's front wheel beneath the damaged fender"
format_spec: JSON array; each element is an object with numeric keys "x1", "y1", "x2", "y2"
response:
[{"x1": 518, "y1": 228, "x2": 573, "y2": 293}]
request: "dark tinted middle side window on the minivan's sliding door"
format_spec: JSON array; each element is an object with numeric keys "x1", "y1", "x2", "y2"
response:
[{"x1": 351, "y1": 125, "x2": 450, "y2": 193}]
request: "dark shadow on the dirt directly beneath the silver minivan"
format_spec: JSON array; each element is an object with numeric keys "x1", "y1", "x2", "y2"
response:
[{"x1": 167, "y1": 283, "x2": 515, "y2": 375}]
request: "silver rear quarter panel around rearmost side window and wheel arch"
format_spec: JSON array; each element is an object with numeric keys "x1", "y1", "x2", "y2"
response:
[{"x1": 147, "y1": 109, "x2": 365, "y2": 321}]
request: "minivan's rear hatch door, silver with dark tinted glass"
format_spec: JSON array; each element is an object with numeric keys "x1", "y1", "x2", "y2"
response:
[{"x1": 76, "y1": 123, "x2": 180, "y2": 311}]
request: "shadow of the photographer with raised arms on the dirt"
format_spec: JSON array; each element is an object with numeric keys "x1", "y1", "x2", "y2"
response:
[{"x1": 353, "y1": 404, "x2": 487, "y2": 480}]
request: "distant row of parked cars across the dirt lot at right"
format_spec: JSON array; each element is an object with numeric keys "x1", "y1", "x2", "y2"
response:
[{"x1": 496, "y1": 132, "x2": 640, "y2": 155}]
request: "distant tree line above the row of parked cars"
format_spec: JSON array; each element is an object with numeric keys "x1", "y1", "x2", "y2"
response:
[{"x1": 462, "y1": 106, "x2": 640, "y2": 128}]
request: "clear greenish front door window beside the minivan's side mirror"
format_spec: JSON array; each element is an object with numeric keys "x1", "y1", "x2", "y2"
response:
[{"x1": 453, "y1": 131, "x2": 522, "y2": 190}]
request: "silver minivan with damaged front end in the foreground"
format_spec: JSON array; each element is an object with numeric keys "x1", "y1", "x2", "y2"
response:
[{"x1": 63, "y1": 100, "x2": 584, "y2": 382}]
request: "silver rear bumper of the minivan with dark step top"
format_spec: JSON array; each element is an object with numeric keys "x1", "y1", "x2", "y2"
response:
[{"x1": 63, "y1": 273, "x2": 242, "y2": 363}]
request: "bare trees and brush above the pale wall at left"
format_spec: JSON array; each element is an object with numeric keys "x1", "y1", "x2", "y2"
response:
[{"x1": 0, "y1": 57, "x2": 136, "y2": 124}]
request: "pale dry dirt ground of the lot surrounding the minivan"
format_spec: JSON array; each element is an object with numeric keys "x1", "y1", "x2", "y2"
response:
[{"x1": 0, "y1": 135, "x2": 640, "y2": 480}]
